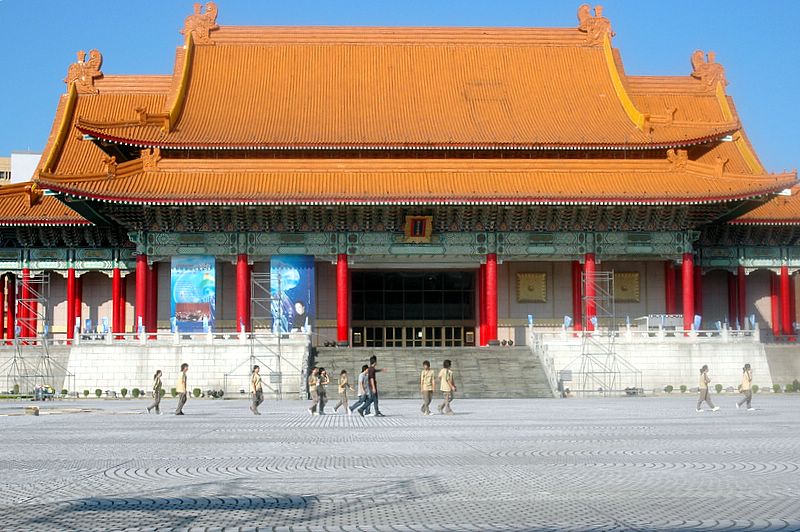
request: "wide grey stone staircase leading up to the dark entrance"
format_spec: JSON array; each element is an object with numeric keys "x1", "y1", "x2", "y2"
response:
[{"x1": 310, "y1": 347, "x2": 553, "y2": 399}]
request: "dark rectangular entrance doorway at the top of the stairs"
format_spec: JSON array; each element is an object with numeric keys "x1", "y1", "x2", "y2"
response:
[{"x1": 351, "y1": 270, "x2": 475, "y2": 347}]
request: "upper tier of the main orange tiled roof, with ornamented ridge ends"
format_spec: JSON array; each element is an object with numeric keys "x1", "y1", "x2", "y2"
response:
[{"x1": 68, "y1": 3, "x2": 740, "y2": 149}]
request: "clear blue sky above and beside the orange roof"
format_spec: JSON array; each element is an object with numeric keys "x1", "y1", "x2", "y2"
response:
[{"x1": 0, "y1": 0, "x2": 800, "y2": 172}]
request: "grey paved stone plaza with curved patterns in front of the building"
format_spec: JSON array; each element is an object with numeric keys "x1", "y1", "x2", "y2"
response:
[{"x1": 0, "y1": 394, "x2": 800, "y2": 531}]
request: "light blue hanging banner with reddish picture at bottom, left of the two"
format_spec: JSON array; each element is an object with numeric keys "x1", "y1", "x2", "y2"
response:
[{"x1": 170, "y1": 256, "x2": 217, "y2": 332}]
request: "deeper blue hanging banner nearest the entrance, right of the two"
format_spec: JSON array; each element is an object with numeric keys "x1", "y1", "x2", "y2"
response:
[{"x1": 269, "y1": 255, "x2": 316, "y2": 332}]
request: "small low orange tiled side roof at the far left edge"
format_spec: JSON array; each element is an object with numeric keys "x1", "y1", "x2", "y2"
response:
[{"x1": 0, "y1": 182, "x2": 90, "y2": 226}]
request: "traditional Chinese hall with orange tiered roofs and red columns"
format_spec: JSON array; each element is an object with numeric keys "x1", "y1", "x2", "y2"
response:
[{"x1": 0, "y1": 3, "x2": 800, "y2": 394}]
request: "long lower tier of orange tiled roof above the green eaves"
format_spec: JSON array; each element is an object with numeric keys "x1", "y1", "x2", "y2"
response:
[{"x1": 38, "y1": 159, "x2": 796, "y2": 205}]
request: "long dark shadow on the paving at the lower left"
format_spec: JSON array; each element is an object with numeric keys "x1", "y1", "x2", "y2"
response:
[{"x1": 7, "y1": 477, "x2": 444, "y2": 530}]
